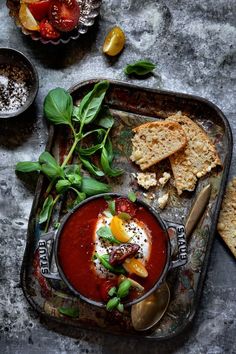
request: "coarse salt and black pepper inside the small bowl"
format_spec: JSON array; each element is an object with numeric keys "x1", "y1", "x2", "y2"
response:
[{"x1": 0, "y1": 64, "x2": 29, "y2": 112}]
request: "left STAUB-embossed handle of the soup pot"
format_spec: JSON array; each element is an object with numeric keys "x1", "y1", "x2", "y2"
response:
[{"x1": 38, "y1": 231, "x2": 61, "y2": 280}]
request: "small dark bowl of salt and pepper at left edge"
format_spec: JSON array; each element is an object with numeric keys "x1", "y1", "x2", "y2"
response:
[{"x1": 0, "y1": 48, "x2": 39, "y2": 119}]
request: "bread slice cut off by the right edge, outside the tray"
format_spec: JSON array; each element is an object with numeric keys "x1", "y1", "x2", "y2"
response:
[{"x1": 217, "y1": 177, "x2": 236, "y2": 257}]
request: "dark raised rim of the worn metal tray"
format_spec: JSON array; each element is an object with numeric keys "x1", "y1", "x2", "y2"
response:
[{"x1": 20, "y1": 78, "x2": 233, "y2": 341}]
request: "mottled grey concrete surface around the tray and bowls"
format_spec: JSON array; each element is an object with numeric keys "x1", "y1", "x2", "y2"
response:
[{"x1": 0, "y1": 0, "x2": 236, "y2": 354}]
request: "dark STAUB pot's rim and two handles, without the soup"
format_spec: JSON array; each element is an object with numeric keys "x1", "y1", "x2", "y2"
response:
[{"x1": 38, "y1": 193, "x2": 187, "y2": 307}]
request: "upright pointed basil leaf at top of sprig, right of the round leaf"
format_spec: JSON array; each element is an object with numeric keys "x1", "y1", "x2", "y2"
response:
[{"x1": 79, "y1": 80, "x2": 109, "y2": 124}]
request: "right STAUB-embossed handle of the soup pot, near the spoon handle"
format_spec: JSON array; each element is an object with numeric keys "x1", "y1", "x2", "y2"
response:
[{"x1": 165, "y1": 220, "x2": 188, "y2": 269}]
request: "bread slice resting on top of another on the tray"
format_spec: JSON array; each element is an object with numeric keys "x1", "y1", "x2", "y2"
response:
[{"x1": 130, "y1": 121, "x2": 187, "y2": 170}]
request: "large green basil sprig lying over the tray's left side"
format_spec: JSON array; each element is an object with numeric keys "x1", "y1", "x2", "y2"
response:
[{"x1": 16, "y1": 80, "x2": 122, "y2": 231}]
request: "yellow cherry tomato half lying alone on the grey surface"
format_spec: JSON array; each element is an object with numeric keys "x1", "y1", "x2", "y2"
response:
[{"x1": 103, "y1": 27, "x2": 125, "y2": 57}]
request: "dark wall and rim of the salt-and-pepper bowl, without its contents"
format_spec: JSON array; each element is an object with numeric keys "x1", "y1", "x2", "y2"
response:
[{"x1": 0, "y1": 48, "x2": 39, "y2": 119}]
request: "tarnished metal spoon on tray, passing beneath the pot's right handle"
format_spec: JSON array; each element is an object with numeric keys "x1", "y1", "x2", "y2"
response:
[{"x1": 131, "y1": 184, "x2": 211, "y2": 331}]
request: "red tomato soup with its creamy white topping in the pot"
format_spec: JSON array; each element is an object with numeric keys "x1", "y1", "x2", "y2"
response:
[{"x1": 57, "y1": 197, "x2": 168, "y2": 302}]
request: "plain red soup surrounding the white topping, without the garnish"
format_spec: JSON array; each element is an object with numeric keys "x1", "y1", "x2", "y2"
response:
[{"x1": 56, "y1": 197, "x2": 169, "y2": 303}]
